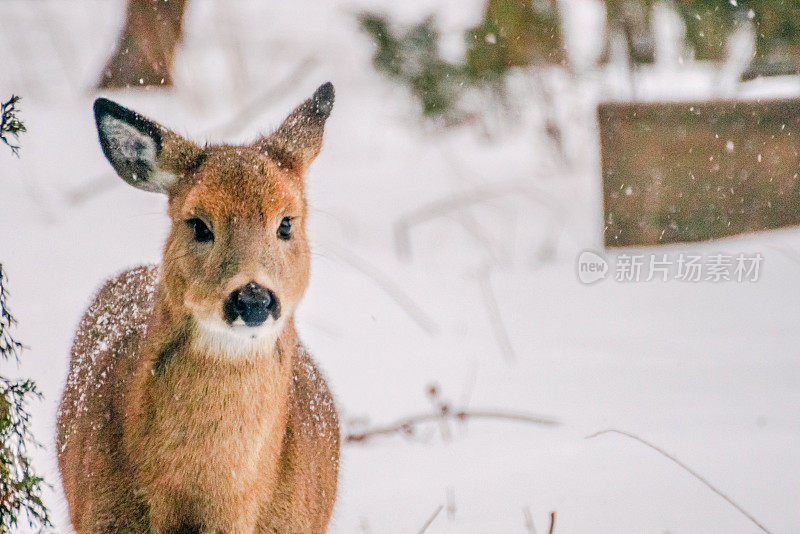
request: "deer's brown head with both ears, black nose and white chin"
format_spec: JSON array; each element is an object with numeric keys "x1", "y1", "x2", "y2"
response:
[{"x1": 94, "y1": 83, "x2": 334, "y2": 355}]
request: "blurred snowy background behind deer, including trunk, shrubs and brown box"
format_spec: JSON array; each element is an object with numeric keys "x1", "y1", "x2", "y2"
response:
[{"x1": 0, "y1": 0, "x2": 800, "y2": 533}]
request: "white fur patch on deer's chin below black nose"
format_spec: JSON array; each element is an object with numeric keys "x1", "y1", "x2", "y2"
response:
[{"x1": 194, "y1": 318, "x2": 283, "y2": 358}]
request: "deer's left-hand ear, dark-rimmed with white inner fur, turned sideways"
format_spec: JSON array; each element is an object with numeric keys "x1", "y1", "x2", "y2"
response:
[{"x1": 94, "y1": 98, "x2": 202, "y2": 193}]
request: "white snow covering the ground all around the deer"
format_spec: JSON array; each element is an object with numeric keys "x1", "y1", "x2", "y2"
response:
[{"x1": 0, "y1": 0, "x2": 800, "y2": 534}]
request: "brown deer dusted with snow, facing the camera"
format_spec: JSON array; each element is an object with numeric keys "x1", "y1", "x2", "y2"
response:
[{"x1": 56, "y1": 82, "x2": 339, "y2": 534}]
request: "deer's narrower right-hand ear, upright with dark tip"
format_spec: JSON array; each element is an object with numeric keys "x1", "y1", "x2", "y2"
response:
[{"x1": 255, "y1": 82, "x2": 334, "y2": 174}]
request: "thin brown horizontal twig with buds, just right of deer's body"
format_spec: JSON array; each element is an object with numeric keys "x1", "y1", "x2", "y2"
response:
[{"x1": 344, "y1": 410, "x2": 559, "y2": 443}]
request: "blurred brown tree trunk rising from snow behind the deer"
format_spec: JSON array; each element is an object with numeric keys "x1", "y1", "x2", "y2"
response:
[{"x1": 98, "y1": 0, "x2": 186, "y2": 89}]
